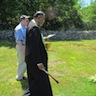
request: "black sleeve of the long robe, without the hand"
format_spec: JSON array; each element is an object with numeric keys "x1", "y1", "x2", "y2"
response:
[{"x1": 29, "y1": 27, "x2": 42, "y2": 65}]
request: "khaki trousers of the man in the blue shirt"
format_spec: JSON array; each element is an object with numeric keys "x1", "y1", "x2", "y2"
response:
[{"x1": 16, "y1": 44, "x2": 26, "y2": 79}]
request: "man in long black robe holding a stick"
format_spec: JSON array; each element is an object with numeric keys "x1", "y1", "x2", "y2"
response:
[{"x1": 23, "y1": 11, "x2": 53, "y2": 96}]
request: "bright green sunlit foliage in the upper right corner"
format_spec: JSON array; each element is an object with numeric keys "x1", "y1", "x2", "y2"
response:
[{"x1": 80, "y1": 0, "x2": 96, "y2": 30}]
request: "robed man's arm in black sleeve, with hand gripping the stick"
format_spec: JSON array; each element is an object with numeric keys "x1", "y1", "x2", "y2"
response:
[{"x1": 30, "y1": 27, "x2": 45, "y2": 70}]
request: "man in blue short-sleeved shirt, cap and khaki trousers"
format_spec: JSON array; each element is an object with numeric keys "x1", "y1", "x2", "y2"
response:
[{"x1": 15, "y1": 15, "x2": 29, "y2": 81}]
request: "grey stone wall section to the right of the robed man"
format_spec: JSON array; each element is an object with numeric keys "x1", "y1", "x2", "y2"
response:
[{"x1": 43, "y1": 31, "x2": 96, "y2": 40}]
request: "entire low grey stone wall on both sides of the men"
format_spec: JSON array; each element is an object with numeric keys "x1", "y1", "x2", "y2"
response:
[{"x1": 0, "y1": 30, "x2": 96, "y2": 40}]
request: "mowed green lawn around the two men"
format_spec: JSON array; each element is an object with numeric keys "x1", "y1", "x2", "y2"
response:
[{"x1": 0, "y1": 40, "x2": 96, "y2": 96}]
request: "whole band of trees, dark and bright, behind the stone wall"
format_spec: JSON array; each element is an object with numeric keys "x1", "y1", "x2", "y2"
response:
[{"x1": 0, "y1": 0, "x2": 96, "y2": 30}]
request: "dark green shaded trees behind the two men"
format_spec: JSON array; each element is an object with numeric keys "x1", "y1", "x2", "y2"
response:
[{"x1": 0, "y1": 0, "x2": 83, "y2": 30}]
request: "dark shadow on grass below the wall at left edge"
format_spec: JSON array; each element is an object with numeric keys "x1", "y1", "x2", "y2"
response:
[{"x1": 0, "y1": 40, "x2": 16, "y2": 48}]
